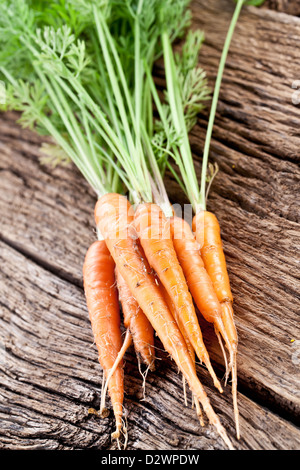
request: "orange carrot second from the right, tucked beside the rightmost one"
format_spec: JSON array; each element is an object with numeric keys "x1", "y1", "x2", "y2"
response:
[{"x1": 170, "y1": 216, "x2": 231, "y2": 375}]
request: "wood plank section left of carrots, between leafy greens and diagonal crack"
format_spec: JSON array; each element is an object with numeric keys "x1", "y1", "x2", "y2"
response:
[{"x1": 0, "y1": 113, "x2": 95, "y2": 284}]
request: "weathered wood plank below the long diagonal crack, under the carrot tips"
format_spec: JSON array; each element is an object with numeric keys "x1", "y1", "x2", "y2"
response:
[{"x1": 0, "y1": 243, "x2": 300, "y2": 450}]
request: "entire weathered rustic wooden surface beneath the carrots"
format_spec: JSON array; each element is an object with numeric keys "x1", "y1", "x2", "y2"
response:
[{"x1": 0, "y1": 0, "x2": 300, "y2": 450}]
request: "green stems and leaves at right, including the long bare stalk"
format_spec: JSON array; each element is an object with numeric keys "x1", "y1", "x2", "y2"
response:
[{"x1": 151, "y1": 0, "x2": 263, "y2": 213}]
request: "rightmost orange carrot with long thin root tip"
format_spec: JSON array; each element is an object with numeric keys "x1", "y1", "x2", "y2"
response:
[{"x1": 193, "y1": 211, "x2": 240, "y2": 437}]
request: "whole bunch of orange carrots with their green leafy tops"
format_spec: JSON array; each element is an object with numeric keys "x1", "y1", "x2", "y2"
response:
[{"x1": 0, "y1": 0, "x2": 261, "y2": 449}]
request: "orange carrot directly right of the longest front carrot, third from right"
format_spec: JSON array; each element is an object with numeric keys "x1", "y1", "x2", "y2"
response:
[{"x1": 135, "y1": 203, "x2": 222, "y2": 391}]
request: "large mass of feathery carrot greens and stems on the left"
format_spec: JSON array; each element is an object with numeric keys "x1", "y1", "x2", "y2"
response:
[{"x1": 0, "y1": 0, "x2": 202, "y2": 209}]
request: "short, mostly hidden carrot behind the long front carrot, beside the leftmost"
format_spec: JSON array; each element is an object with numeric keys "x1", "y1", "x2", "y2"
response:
[{"x1": 116, "y1": 269, "x2": 154, "y2": 371}]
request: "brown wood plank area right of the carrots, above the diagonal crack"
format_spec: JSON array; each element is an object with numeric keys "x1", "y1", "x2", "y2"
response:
[{"x1": 162, "y1": 0, "x2": 300, "y2": 422}]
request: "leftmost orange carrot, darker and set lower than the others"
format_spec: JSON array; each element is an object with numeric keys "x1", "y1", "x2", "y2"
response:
[{"x1": 83, "y1": 240, "x2": 129, "y2": 439}]
